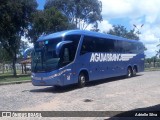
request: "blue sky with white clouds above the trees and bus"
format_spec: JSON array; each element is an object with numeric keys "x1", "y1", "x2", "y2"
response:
[{"x1": 37, "y1": 0, "x2": 160, "y2": 57}]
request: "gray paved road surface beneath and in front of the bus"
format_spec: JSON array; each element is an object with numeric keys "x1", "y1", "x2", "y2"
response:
[{"x1": 0, "y1": 71, "x2": 160, "y2": 119}]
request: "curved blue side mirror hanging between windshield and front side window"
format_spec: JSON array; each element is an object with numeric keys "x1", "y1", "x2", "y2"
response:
[{"x1": 56, "y1": 41, "x2": 72, "y2": 56}]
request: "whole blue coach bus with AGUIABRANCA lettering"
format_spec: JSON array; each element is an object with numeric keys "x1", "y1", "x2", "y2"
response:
[{"x1": 24, "y1": 30, "x2": 145, "y2": 87}]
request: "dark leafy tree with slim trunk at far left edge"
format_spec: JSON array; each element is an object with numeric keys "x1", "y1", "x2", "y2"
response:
[{"x1": 0, "y1": 0, "x2": 37, "y2": 76}]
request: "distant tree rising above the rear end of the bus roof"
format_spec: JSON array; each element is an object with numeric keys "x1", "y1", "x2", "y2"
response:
[{"x1": 107, "y1": 25, "x2": 139, "y2": 40}]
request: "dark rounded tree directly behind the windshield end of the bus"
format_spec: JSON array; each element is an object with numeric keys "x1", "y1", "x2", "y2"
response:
[{"x1": 28, "y1": 7, "x2": 75, "y2": 43}]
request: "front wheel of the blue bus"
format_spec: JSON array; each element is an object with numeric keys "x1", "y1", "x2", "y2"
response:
[{"x1": 78, "y1": 73, "x2": 87, "y2": 88}]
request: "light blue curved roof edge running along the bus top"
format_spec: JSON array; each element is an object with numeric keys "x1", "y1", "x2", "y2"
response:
[{"x1": 38, "y1": 30, "x2": 139, "y2": 42}]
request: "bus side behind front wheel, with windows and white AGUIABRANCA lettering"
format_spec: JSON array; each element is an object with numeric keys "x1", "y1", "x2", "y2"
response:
[{"x1": 79, "y1": 35, "x2": 145, "y2": 81}]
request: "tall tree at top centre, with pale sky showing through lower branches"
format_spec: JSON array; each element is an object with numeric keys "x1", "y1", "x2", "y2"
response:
[{"x1": 45, "y1": 0, "x2": 102, "y2": 29}]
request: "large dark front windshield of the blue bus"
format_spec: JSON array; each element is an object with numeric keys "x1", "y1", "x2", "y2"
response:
[{"x1": 32, "y1": 38, "x2": 62, "y2": 72}]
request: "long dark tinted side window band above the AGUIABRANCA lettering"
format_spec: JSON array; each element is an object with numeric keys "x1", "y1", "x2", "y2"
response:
[{"x1": 81, "y1": 36, "x2": 144, "y2": 54}]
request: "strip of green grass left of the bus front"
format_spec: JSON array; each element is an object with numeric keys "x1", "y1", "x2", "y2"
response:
[{"x1": 0, "y1": 73, "x2": 31, "y2": 83}]
